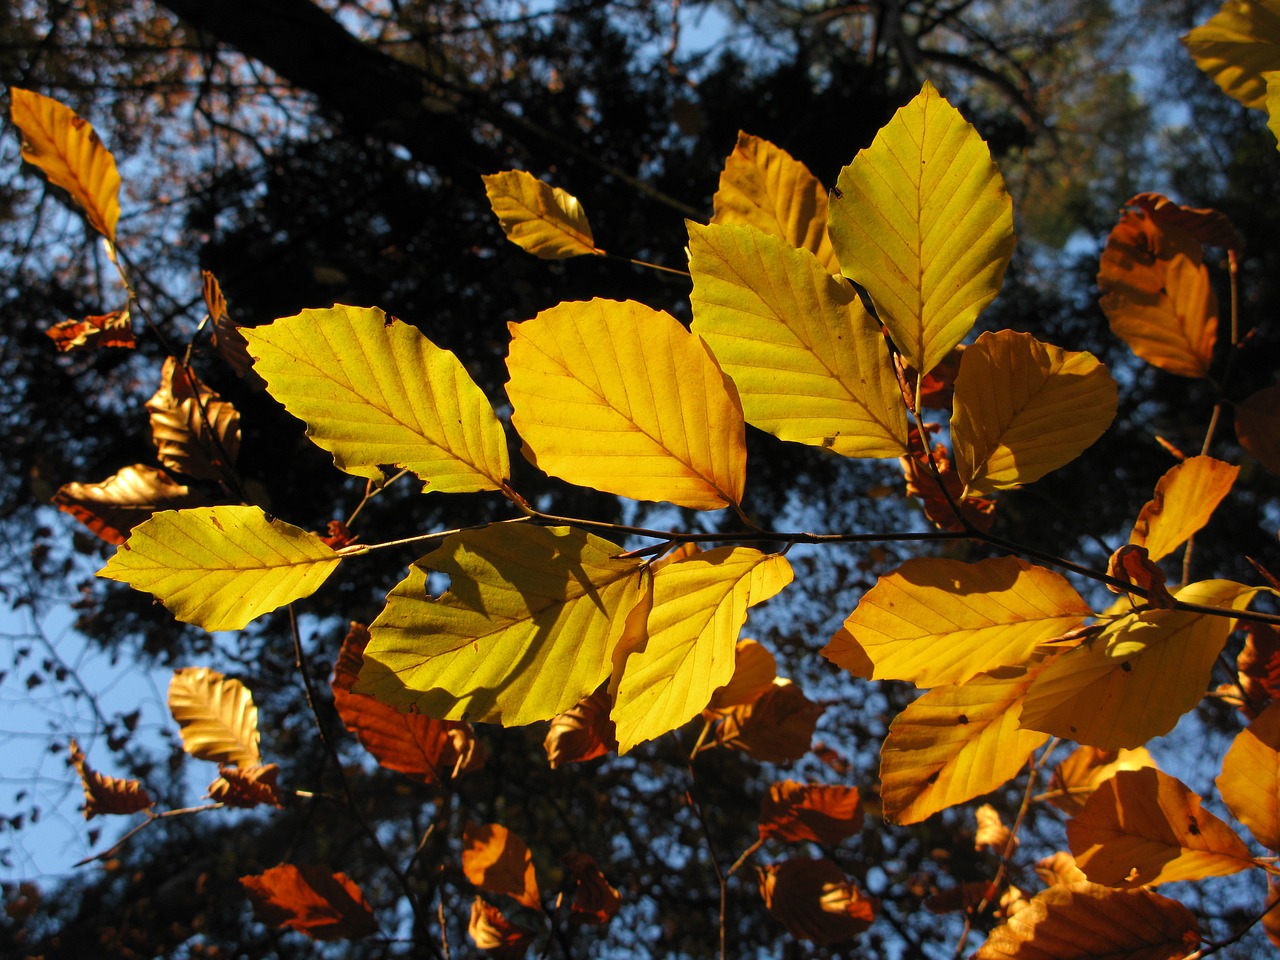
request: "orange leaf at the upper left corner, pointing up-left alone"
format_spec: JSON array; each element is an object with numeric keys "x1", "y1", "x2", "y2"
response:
[{"x1": 9, "y1": 87, "x2": 120, "y2": 244}]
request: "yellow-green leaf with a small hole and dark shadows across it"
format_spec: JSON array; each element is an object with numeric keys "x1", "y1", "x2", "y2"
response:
[{"x1": 355, "y1": 525, "x2": 641, "y2": 726}]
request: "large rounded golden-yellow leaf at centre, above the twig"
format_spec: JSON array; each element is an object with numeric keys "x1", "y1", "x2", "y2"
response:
[{"x1": 507, "y1": 300, "x2": 746, "y2": 509}]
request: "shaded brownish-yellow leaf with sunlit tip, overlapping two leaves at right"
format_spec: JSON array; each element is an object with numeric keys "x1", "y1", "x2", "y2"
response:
[{"x1": 1023, "y1": 580, "x2": 1258, "y2": 750}]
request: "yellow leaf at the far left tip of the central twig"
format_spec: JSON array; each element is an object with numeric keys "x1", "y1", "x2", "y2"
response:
[{"x1": 97, "y1": 507, "x2": 339, "y2": 631}]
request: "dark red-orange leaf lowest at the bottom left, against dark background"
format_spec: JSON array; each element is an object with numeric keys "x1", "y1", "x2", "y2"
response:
[{"x1": 241, "y1": 864, "x2": 378, "y2": 940}]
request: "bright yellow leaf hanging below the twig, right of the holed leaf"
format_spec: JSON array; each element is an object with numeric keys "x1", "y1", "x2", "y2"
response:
[{"x1": 611, "y1": 547, "x2": 792, "y2": 753}]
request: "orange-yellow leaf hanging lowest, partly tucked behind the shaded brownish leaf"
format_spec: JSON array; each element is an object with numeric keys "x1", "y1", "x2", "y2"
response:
[{"x1": 881, "y1": 664, "x2": 1048, "y2": 823}]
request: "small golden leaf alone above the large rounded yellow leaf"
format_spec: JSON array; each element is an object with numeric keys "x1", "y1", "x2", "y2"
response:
[{"x1": 483, "y1": 170, "x2": 604, "y2": 260}]
